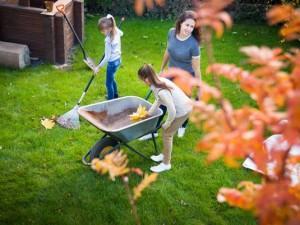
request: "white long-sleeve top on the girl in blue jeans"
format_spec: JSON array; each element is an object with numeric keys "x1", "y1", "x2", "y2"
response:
[{"x1": 98, "y1": 28, "x2": 123, "y2": 68}]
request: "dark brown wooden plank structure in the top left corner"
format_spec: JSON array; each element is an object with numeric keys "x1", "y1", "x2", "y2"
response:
[{"x1": 0, "y1": 0, "x2": 84, "y2": 64}]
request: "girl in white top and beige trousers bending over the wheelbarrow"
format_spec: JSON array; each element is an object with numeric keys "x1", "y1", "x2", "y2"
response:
[{"x1": 138, "y1": 64, "x2": 192, "y2": 173}]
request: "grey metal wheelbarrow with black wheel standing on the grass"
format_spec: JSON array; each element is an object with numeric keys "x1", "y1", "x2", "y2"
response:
[{"x1": 78, "y1": 96, "x2": 163, "y2": 165}]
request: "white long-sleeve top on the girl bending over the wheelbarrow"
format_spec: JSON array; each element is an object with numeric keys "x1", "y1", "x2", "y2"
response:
[{"x1": 149, "y1": 77, "x2": 193, "y2": 128}]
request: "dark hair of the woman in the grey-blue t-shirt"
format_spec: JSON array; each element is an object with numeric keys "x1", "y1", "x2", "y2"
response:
[{"x1": 175, "y1": 10, "x2": 201, "y2": 43}]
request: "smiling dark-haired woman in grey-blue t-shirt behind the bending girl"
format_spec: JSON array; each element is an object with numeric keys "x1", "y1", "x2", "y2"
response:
[{"x1": 161, "y1": 11, "x2": 201, "y2": 137}]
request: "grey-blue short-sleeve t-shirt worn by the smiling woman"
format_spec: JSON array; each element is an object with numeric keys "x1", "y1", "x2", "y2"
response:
[{"x1": 168, "y1": 28, "x2": 200, "y2": 74}]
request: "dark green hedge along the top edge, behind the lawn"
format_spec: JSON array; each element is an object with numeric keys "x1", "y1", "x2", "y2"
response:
[{"x1": 85, "y1": 0, "x2": 297, "y2": 21}]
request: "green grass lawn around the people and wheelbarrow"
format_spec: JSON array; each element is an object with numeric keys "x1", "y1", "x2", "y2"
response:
[{"x1": 0, "y1": 17, "x2": 288, "y2": 225}]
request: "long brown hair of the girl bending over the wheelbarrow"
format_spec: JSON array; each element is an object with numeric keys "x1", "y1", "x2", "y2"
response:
[{"x1": 138, "y1": 64, "x2": 171, "y2": 91}]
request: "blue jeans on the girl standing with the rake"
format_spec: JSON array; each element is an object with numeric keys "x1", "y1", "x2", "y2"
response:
[{"x1": 106, "y1": 59, "x2": 121, "y2": 100}]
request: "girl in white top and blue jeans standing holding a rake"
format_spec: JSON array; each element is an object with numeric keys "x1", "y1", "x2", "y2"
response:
[{"x1": 95, "y1": 14, "x2": 123, "y2": 100}]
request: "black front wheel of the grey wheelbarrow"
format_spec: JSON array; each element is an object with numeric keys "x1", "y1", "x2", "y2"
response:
[{"x1": 90, "y1": 137, "x2": 119, "y2": 161}]
